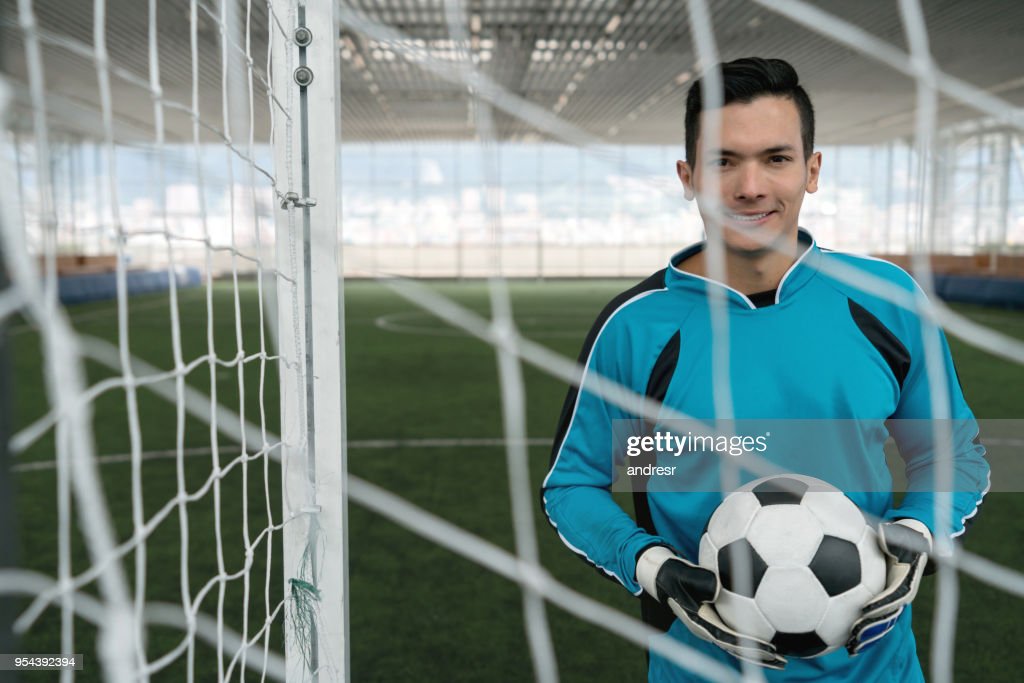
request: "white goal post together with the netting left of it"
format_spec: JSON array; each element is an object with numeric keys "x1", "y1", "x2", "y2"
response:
[{"x1": 0, "y1": 0, "x2": 346, "y2": 681}]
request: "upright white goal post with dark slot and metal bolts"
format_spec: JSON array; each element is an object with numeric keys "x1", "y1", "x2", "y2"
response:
[{"x1": 270, "y1": 0, "x2": 349, "y2": 681}]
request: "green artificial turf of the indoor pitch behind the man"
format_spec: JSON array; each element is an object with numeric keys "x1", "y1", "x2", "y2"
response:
[{"x1": 11, "y1": 281, "x2": 1024, "y2": 681}]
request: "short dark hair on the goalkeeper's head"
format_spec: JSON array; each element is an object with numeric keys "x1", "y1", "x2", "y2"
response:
[{"x1": 684, "y1": 57, "x2": 814, "y2": 165}]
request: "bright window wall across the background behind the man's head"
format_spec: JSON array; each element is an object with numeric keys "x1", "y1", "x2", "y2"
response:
[{"x1": 7, "y1": 130, "x2": 1024, "y2": 276}]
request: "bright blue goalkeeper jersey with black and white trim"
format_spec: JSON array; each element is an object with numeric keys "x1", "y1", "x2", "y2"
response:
[{"x1": 541, "y1": 229, "x2": 989, "y2": 682}]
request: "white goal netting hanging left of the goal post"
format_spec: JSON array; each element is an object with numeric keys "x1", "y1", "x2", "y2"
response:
[{"x1": 3, "y1": 1, "x2": 296, "y2": 681}]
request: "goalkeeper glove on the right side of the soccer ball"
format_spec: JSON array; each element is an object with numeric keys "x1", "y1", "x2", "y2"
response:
[{"x1": 846, "y1": 519, "x2": 932, "y2": 654}]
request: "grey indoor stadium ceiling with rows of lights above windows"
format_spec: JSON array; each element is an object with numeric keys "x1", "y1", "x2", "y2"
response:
[{"x1": 0, "y1": 0, "x2": 1024, "y2": 143}]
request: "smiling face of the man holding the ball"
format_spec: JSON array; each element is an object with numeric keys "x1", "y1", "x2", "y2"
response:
[{"x1": 676, "y1": 95, "x2": 821, "y2": 253}]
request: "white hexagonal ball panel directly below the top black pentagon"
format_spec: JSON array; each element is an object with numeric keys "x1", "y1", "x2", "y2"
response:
[{"x1": 746, "y1": 505, "x2": 822, "y2": 566}]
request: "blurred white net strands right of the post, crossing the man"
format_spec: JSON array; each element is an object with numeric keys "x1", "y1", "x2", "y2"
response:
[{"x1": 331, "y1": 1, "x2": 1024, "y2": 680}]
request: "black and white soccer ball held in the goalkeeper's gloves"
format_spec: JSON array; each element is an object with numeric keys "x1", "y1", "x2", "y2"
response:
[{"x1": 699, "y1": 474, "x2": 886, "y2": 657}]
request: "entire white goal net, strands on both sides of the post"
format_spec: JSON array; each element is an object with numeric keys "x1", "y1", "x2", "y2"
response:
[{"x1": 0, "y1": 0, "x2": 1024, "y2": 681}]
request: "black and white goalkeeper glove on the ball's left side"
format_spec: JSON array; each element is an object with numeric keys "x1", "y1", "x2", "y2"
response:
[{"x1": 637, "y1": 546, "x2": 786, "y2": 669}]
